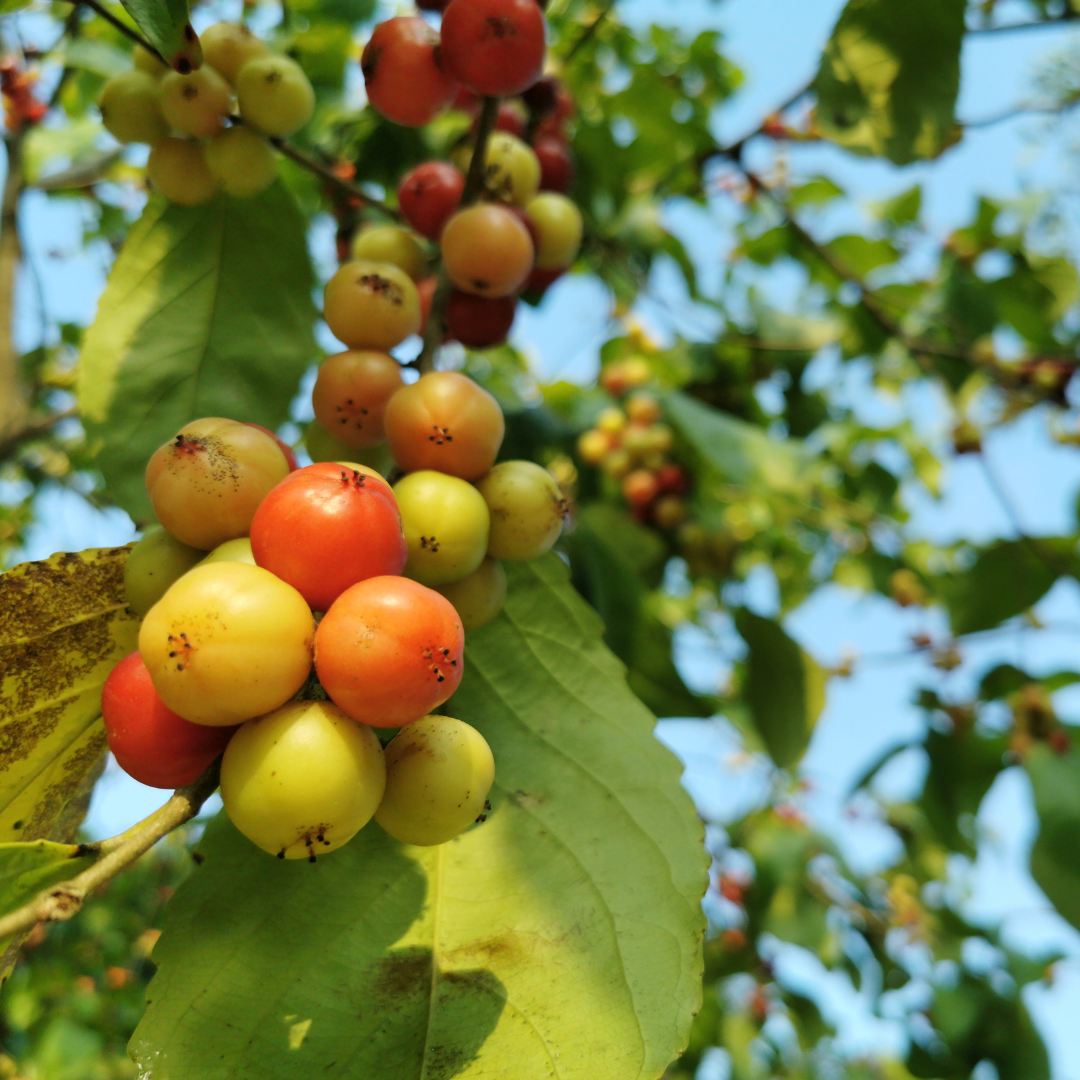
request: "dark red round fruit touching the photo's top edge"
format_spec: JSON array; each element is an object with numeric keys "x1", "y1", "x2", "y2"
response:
[{"x1": 442, "y1": 0, "x2": 545, "y2": 97}]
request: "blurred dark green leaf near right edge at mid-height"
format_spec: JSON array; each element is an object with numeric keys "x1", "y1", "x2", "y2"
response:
[{"x1": 939, "y1": 537, "x2": 1074, "y2": 634}]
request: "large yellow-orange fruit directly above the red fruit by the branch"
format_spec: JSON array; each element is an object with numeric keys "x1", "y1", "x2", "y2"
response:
[{"x1": 138, "y1": 563, "x2": 314, "y2": 727}]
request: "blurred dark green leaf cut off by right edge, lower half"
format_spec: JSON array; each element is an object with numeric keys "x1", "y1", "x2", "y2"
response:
[{"x1": 1024, "y1": 745, "x2": 1080, "y2": 929}]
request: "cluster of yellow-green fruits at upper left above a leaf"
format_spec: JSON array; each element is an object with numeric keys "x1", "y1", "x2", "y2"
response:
[{"x1": 98, "y1": 23, "x2": 315, "y2": 206}]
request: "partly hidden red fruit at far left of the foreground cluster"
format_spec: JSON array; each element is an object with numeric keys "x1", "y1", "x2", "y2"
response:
[{"x1": 102, "y1": 652, "x2": 237, "y2": 787}]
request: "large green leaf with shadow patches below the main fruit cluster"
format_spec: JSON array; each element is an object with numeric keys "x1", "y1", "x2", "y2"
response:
[{"x1": 131, "y1": 555, "x2": 706, "y2": 1080}]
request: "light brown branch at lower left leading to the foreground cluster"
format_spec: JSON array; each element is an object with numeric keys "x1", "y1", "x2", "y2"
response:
[{"x1": 0, "y1": 759, "x2": 220, "y2": 940}]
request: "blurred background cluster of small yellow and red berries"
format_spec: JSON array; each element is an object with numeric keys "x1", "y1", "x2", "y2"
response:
[{"x1": 578, "y1": 357, "x2": 687, "y2": 532}]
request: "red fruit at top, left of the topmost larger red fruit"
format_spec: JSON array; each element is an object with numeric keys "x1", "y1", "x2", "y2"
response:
[{"x1": 360, "y1": 15, "x2": 458, "y2": 127}]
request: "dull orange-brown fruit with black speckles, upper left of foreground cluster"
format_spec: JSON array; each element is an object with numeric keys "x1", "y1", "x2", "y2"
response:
[{"x1": 146, "y1": 417, "x2": 288, "y2": 551}]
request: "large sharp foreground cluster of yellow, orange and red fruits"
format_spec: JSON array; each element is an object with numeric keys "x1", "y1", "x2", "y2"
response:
[{"x1": 102, "y1": 369, "x2": 565, "y2": 860}]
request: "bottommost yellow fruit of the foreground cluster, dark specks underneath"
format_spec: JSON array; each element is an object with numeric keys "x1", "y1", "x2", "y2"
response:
[{"x1": 221, "y1": 701, "x2": 387, "y2": 862}]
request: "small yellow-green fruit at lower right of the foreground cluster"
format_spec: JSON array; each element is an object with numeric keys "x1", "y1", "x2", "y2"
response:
[{"x1": 375, "y1": 716, "x2": 495, "y2": 847}]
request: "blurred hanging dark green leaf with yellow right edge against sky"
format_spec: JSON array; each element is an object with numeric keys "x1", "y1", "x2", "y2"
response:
[{"x1": 735, "y1": 608, "x2": 826, "y2": 769}]
